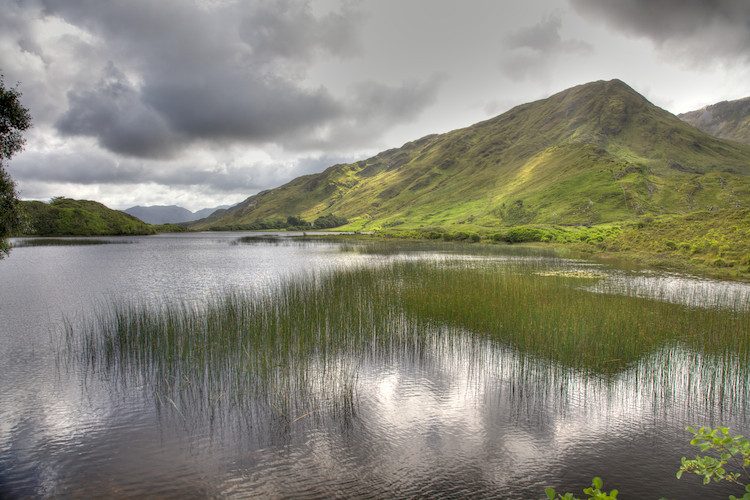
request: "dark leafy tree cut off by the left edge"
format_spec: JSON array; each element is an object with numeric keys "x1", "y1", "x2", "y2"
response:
[{"x1": 0, "y1": 75, "x2": 31, "y2": 259}]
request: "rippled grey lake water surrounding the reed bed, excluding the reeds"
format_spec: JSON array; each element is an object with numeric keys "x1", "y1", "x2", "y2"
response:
[{"x1": 0, "y1": 233, "x2": 750, "y2": 499}]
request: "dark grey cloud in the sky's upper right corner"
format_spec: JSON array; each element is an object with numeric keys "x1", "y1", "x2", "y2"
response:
[{"x1": 570, "y1": 0, "x2": 750, "y2": 64}]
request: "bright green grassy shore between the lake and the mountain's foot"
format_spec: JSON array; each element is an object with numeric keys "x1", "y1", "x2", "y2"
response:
[{"x1": 338, "y1": 209, "x2": 750, "y2": 281}]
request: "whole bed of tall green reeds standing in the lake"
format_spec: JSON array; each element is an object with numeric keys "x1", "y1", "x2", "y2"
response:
[{"x1": 65, "y1": 259, "x2": 750, "y2": 422}]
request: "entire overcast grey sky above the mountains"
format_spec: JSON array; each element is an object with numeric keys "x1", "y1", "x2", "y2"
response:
[{"x1": 0, "y1": 0, "x2": 750, "y2": 210}]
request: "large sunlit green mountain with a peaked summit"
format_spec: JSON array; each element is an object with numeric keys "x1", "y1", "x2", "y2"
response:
[{"x1": 193, "y1": 80, "x2": 750, "y2": 232}]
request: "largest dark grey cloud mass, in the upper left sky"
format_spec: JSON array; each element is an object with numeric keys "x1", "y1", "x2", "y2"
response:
[{"x1": 33, "y1": 0, "x2": 435, "y2": 159}]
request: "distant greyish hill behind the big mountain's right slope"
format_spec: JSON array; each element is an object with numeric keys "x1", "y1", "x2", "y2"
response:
[{"x1": 677, "y1": 97, "x2": 750, "y2": 144}]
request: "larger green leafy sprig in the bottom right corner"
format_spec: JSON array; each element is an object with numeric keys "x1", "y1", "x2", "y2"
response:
[{"x1": 677, "y1": 427, "x2": 750, "y2": 500}]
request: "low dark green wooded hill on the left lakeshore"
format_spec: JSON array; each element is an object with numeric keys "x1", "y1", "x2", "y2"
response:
[{"x1": 23, "y1": 198, "x2": 156, "y2": 236}]
